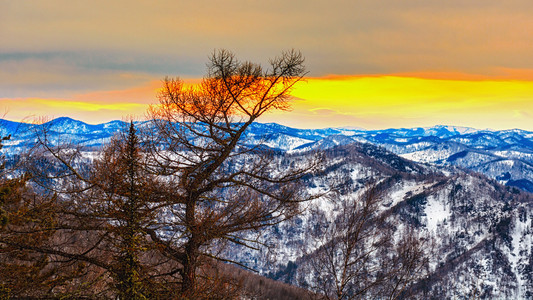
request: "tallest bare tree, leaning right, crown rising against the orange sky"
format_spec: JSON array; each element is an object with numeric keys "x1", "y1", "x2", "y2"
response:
[{"x1": 143, "y1": 50, "x2": 316, "y2": 297}]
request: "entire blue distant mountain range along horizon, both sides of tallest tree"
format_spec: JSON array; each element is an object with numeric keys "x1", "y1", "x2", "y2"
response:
[{"x1": 0, "y1": 117, "x2": 533, "y2": 192}]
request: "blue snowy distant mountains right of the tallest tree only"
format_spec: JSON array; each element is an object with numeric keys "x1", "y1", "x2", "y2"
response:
[{"x1": 244, "y1": 124, "x2": 533, "y2": 192}]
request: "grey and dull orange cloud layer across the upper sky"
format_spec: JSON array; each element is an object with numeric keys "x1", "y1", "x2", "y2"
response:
[{"x1": 0, "y1": 0, "x2": 533, "y2": 95}]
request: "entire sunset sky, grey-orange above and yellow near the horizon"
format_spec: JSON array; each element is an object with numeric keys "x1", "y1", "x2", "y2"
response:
[{"x1": 0, "y1": 0, "x2": 533, "y2": 130}]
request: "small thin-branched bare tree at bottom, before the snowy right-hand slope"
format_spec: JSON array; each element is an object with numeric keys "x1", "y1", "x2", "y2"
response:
[{"x1": 300, "y1": 188, "x2": 428, "y2": 299}]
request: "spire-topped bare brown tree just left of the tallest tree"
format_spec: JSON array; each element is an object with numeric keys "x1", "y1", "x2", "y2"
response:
[{"x1": 8, "y1": 123, "x2": 183, "y2": 299}]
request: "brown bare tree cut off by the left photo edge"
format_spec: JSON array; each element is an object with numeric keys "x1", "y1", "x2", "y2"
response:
[{"x1": 0, "y1": 137, "x2": 97, "y2": 299}]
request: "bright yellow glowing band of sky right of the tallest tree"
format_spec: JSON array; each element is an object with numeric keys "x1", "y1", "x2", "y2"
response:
[{"x1": 263, "y1": 76, "x2": 533, "y2": 130}]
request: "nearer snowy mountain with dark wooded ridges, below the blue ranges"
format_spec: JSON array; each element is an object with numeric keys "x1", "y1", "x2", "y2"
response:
[{"x1": 244, "y1": 143, "x2": 533, "y2": 299}]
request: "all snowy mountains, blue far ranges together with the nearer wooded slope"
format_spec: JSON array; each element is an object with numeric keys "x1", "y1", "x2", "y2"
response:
[{"x1": 0, "y1": 118, "x2": 533, "y2": 299}]
